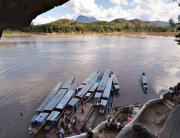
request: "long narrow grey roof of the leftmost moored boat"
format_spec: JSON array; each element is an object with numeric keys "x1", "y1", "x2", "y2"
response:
[{"x1": 36, "y1": 82, "x2": 62, "y2": 112}]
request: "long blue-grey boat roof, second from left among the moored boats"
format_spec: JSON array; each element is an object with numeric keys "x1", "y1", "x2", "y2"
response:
[{"x1": 44, "y1": 89, "x2": 67, "y2": 111}]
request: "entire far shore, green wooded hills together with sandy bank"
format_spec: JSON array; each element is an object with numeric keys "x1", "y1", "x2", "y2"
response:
[{"x1": 3, "y1": 19, "x2": 179, "y2": 36}]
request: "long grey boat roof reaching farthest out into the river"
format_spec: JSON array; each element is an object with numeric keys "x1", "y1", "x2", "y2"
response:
[{"x1": 96, "y1": 69, "x2": 111, "y2": 92}]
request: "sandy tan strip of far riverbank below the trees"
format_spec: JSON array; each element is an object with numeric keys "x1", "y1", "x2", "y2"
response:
[{"x1": 3, "y1": 31, "x2": 176, "y2": 37}]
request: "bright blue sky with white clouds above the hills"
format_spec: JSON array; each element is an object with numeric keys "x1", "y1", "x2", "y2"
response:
[{"x1": 33, "y1": 0, "x2": 180, "y2": 24}]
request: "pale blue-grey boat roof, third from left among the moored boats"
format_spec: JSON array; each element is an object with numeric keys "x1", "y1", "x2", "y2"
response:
[{"x1": 56, "y1": 90, "x2": 75, "y2": 110}]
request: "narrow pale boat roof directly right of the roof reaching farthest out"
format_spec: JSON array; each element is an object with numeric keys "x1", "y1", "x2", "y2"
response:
[{"x1": 102, "y1": 77, "x2": 112, "y2": 100}]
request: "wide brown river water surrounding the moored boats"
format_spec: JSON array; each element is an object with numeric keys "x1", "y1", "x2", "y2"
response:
[{"x1": 0, "y1": 36, "x2": 180, "y2": 138}]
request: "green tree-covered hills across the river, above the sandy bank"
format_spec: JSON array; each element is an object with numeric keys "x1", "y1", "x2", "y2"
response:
[{"x1": 21, "y1": 19, "x2": 174, "y2": 33}]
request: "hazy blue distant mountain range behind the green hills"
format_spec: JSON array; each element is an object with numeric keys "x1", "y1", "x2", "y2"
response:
[{"x1": 73, "y1": 15, "x2": 169, "y2": 26}]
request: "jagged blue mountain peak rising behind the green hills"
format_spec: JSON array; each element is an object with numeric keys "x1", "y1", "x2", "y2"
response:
[{"x1": 75, "y1": 15, "x2": 98, "y2": 23}]
